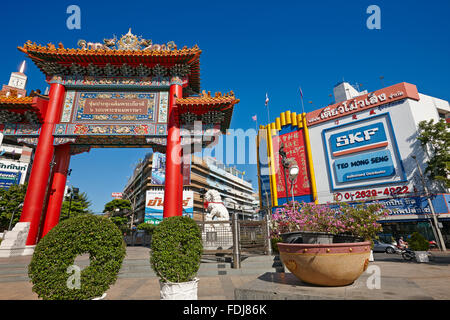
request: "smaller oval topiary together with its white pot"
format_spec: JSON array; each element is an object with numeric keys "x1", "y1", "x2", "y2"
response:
[{"x1": 150, "y1": 216, "x2": 203, "y2": 300}]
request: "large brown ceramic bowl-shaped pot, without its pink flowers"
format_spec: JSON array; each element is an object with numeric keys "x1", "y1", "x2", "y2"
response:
[{"x1": 277, "y1": 241, "x2": 371, "y2": 287}]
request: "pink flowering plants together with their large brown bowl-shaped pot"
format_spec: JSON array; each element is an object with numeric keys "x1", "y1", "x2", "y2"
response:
[{"x1": 272, "y1": 203, "x2": 387, "y2": 286}]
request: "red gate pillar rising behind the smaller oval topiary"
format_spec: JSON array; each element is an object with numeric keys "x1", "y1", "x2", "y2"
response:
[{"x1": 163, "y1": 80, "x2": 183, "y2": 218}]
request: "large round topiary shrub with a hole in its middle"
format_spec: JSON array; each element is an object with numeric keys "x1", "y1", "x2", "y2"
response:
[{"x1": 28, "y1": 215, "x2": 125, "y2": 300}]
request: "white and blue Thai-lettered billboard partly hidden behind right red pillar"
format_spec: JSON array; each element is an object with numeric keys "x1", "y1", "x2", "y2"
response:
[{"x1": 144, "y1": 188, "x2": 194, "y2": 224}]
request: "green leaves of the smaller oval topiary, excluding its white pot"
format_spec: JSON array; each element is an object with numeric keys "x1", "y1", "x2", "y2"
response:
[{"x1": 150, "y1": 216, "x2": 203, "y2": 282}]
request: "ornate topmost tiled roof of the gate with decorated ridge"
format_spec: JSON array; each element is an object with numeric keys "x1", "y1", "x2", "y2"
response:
[{"x1": 18, "y1": 30, "x2": 202, "y2": 93}]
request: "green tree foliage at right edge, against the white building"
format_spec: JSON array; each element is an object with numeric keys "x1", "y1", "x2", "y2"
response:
[{"x1": 417, "y1": 119, "x2": 450, "y2": 188}]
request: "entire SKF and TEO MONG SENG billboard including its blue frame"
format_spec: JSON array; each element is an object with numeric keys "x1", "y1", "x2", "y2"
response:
[{"x1": 322, "y1": 113, "x2": 406, "y2": 191}]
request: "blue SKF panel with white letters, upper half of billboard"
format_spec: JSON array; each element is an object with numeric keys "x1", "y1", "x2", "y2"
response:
[{"x1": 330, "y1": 122, "x2": 388, "y2": 157}]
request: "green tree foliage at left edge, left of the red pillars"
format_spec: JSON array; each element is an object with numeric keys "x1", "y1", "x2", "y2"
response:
[{"x1": 0, "y1": 184, "x2": 27, "y2": 230}]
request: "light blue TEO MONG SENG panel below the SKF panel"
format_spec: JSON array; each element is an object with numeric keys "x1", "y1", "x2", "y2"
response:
[{"x1": 334, "y1": 150, "x2": 395, "y2": 183}]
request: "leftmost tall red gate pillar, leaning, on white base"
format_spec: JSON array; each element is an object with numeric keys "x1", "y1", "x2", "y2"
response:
[{"x1": 20, "y1": 83, "x2": 64, "y2": 245}]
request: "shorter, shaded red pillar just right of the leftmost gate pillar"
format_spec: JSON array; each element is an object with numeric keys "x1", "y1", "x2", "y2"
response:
[{"x1": 42, "y1": 144, "x2": 70, "y2": 237}]
